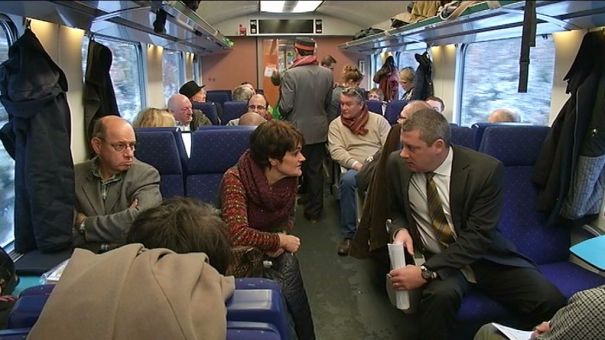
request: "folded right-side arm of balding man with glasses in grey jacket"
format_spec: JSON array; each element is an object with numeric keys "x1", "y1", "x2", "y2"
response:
[{"x1": 84, "y1": 167, "x2": 162, "y2": 243}]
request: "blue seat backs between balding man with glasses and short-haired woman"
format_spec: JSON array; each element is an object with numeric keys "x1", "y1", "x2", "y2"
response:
[{"x1": 135, "y1": 126, "x2": 254, "y2": 203}]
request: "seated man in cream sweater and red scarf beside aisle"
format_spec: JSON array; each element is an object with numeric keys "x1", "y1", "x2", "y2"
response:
[{"x1": 328, "y1": 87, "x2": 391, "y2": 256}]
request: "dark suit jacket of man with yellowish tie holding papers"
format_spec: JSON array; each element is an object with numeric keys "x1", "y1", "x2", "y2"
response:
[{"x1": 387, "y1": 146, "x2": 532, "y2": 278}]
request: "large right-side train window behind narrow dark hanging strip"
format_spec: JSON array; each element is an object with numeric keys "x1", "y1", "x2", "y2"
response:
[{"x1": 459, "y1": 35, "x2": 555, "y2": 126}]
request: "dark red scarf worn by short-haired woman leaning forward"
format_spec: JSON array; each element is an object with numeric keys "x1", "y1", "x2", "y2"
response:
[{"x1": 237, "y1": 150, "x2": 298, "y2": 231}]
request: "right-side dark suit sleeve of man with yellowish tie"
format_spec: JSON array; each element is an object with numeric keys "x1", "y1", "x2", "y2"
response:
[{"x1": 426, "y1": 162, "x2": 504, "y2": 276}]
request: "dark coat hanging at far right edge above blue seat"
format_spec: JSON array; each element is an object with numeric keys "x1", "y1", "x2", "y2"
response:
[{"x1": 533, "y1": 32, "x2": 605, "y2": 223}]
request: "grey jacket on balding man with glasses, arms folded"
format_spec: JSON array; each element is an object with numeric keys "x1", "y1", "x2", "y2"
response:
[{"x1": 74, "y1": 158, "x2": 162, "y2": 246}]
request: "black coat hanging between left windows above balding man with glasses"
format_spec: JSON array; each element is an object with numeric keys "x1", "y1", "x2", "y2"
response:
[{"x1": 84, "y1": 39, "x2": 120, "y2": 155}]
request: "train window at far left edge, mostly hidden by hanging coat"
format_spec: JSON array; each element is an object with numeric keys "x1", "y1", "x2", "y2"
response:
[{"x1": 0, "y1": 17, "x2": 15, "y2": 247}]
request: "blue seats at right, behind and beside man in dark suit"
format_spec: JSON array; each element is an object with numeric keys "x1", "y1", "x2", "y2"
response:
[{"x1": 452, "y1": 124, "x2": 605, "y2": 339}]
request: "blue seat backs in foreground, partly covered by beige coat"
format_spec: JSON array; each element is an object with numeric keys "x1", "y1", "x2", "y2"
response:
[{"x1": 0, "y1": 278, "x2": 291, "y2": 340}]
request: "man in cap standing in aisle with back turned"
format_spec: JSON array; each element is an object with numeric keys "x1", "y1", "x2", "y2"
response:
[{"x1": 279, "y1": 38, "x2": 333, "y2": 221}]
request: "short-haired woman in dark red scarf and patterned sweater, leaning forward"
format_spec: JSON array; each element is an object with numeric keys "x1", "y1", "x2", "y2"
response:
[{"x1": 219, "y1": 120, "x2": 315, "y2": 340}]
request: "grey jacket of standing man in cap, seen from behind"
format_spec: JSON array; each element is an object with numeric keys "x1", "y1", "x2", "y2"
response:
[{"x1": 279, "y1": 65, "x2": 333, "y2": 144}]
